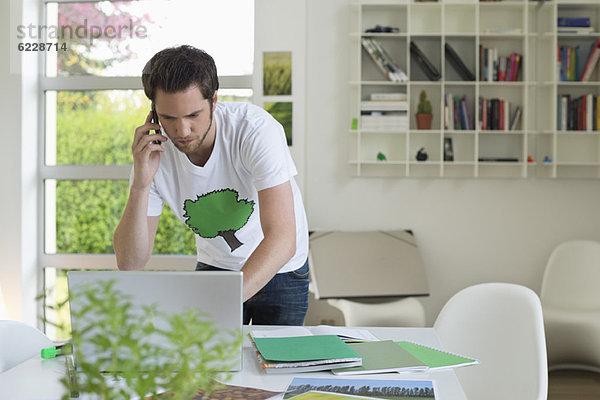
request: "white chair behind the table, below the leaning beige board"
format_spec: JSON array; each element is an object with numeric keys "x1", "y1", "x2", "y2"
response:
[{"x1": 327, "y1": 297, "x2": 425, "y2": 327}]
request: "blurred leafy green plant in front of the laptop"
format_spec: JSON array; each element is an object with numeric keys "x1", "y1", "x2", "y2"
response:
[{"x1": 39, "y1": 281, "x2": 242, "y2": 400}]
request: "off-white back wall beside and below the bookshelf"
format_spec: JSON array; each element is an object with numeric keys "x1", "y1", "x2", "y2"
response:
[{"x1": 305, "y1": 0, "x2": 600, "y2": 324}]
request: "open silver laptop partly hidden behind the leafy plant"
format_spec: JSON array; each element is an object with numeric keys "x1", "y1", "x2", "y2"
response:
[{"x1": 67, "y1": 271, "x2": 243, "y2": 372}]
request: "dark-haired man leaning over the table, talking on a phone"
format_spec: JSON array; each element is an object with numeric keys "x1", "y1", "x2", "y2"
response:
[{"x1": 113, "y1": 46, "x2": 308, "y2": 325}]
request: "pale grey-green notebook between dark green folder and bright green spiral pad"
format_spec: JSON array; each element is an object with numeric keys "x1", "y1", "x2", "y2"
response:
[{"x1": 332, "y1": 340, "x2": 428, "y2": 375}]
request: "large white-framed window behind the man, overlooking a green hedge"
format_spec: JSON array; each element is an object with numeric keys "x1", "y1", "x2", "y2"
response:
[{"x1": 39, "y1": 0, "x2": 254, "y2": 339}]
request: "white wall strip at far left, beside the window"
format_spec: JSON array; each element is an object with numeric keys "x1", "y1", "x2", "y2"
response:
[{"x1": 0, "y1": 0, "x2": 38, "y2": 325}]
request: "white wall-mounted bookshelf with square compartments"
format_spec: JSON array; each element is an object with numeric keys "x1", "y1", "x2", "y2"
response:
[{"x1": 348, "y1": 0, "x2": 600, "y2": 178}]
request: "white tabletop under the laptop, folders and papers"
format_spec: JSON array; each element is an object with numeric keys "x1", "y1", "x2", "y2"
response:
[{"x1": 0, "y1": 326, "x2": 466, "y2": 400}]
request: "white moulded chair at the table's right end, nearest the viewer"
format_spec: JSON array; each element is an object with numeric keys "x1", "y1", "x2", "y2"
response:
[{"x1": 434, "y1": 283, "x2": 548, "y2": 400}]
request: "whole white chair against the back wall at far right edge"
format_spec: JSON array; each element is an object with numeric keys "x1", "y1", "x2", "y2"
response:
[{"x1": 540, "y1": 240, "x2": 600, "y2": 372}]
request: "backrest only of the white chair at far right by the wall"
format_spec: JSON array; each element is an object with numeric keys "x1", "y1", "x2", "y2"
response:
[{"x1": 540, "y1": 240, "x2": 600, "y2": 310}]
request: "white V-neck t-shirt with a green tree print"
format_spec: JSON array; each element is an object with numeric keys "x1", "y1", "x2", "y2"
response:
[{"x1": 148, "y1": 102, "x2": 308, "y2": 273}]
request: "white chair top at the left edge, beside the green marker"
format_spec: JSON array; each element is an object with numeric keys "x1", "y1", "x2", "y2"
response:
[{"x1": 0, "y1": 320, "x2": 53, "y2": 373}]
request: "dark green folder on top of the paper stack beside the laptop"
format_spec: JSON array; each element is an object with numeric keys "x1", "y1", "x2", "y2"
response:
[{"x1": 253, "y1": 335, "x2": 360, "y2": 362}]
